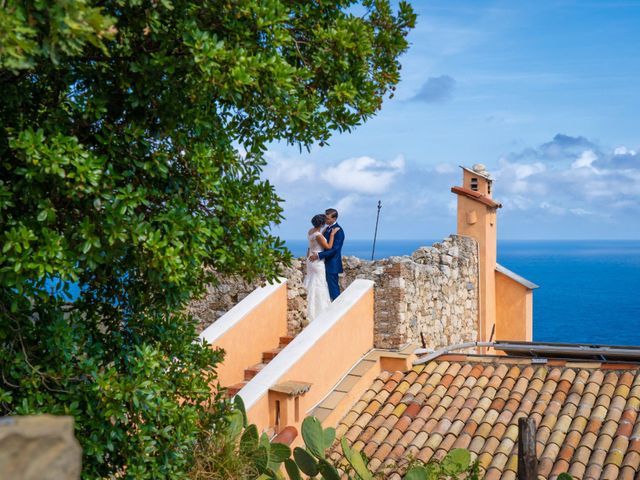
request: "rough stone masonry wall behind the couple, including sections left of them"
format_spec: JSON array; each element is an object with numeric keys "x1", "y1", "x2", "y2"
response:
[{"x1": 190, "y1": 235, "x2": 478, "y2": 348}]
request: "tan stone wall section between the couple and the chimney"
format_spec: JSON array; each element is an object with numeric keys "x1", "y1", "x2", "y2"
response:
[{"x1": 344, "y1": 235, "x2": 478, "y2": 348}]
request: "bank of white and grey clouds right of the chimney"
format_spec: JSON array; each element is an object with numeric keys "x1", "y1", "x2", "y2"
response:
[{"x1": 492, "y1": 135, "x2": 640, "y2": 221}]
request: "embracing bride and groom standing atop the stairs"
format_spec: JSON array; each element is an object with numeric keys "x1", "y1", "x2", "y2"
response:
[{"x1": 304, "y1": 208, "x2": 344, "y2": 321}]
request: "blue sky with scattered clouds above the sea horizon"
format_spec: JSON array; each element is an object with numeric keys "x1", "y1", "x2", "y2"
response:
[{"x1": 265, "y1": 0, "x2": 640, "y2": 239}]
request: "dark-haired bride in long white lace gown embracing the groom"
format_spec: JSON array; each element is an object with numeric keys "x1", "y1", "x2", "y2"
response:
[{"x1": 304, "y1": 214, "x2": 340, "y2": 322}]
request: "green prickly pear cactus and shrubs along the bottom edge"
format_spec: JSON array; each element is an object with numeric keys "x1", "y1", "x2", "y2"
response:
[{"x1": 191, "y1": 397, "x2": 479, "y2": 480}]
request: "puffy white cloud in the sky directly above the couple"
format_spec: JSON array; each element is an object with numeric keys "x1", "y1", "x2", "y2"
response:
[{"x1": 321, "y1": 155, "x2": 405, "y2": 194}]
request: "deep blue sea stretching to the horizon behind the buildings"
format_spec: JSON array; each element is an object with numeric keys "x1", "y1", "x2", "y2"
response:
[{"x1": 287, "y1": 239, "x2": 640, "y2": 345}]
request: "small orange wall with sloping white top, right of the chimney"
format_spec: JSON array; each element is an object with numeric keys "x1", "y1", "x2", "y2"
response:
[{"x1": 495, "y1": 272, "x2": 533, "y2": 342}]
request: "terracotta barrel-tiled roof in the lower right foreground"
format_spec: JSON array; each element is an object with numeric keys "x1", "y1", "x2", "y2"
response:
[{"x1": 334, "y1": 355, "x2": 640, "y2": 479}]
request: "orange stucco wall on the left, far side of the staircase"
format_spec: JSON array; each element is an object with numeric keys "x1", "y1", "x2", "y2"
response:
[{"x1": 213, "y1": 283, "x2": 287, "y2": 387}]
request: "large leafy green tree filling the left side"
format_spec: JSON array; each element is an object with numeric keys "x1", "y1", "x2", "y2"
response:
[{"x1": 0, "y1": 0, "x2": 415, "y2": 479}]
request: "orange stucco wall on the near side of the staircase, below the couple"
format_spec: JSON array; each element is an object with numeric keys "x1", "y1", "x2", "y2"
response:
[{"x1": 241, "y1": 287, "x2": 373, "y2": 438}]
